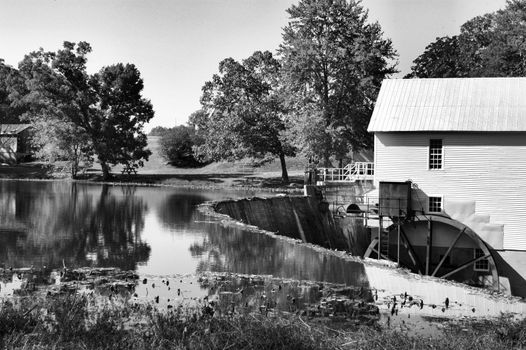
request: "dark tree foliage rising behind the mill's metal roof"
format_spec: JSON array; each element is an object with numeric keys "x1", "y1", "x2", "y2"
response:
[{"x1": 408, "y1": 0, "x2": 526, "y2": 78}]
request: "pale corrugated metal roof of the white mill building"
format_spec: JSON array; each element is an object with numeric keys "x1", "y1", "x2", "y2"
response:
[{"x1": 367, "y1": 78, "x2": 526, "y2": 132}]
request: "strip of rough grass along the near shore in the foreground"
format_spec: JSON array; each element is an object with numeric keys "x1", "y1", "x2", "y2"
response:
[{"x1": 0, "y1": 296, "x2": 526, "y2": 349}]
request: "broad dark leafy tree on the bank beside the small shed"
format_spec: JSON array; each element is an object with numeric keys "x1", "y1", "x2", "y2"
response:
[{"x1": 14, "y1": 42, "x2": 153, "y2": 179}]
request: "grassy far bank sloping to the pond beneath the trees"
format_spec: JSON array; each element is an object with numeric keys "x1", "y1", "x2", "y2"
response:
[{"x1": 0, "y1": 136, "x2": 306, "y2": 190}]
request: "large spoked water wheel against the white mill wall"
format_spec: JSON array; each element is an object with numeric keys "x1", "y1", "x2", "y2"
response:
[{"x1": 365, "y1": 214, "x2": 499, "y2": 290}]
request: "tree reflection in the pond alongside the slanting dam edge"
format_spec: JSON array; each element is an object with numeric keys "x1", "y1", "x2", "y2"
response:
[{"x1": 190, "y1": 217, "x2": 368, "y2": 287}]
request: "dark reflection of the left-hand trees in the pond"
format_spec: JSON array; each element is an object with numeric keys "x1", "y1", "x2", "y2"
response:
[{"x1": 0, "y1": 182, "x2": 150, "y2": 269}]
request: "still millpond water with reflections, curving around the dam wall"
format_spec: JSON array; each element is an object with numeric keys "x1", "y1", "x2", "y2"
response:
[{"x1": 0, "y1": 180, "x2": 526, "y2": 330}]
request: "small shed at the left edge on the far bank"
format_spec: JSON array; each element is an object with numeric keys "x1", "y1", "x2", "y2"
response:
[{"x1": 0, "y1": 124, "x2": 32, "y2": 163}]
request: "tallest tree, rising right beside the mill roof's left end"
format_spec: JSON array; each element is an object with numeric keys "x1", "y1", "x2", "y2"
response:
[{"x1": 279, "y1": 0, "x2": 396, "y2": 161}]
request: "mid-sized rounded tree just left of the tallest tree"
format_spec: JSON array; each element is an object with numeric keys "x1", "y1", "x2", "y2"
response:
[{"x1": 191, "y1": 51, "x2": 294, "y2": 183}]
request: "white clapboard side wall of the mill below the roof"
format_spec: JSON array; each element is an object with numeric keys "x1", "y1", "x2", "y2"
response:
[{"x1": 374, "y1": 132, "x2": 526, "y2": 250}]
